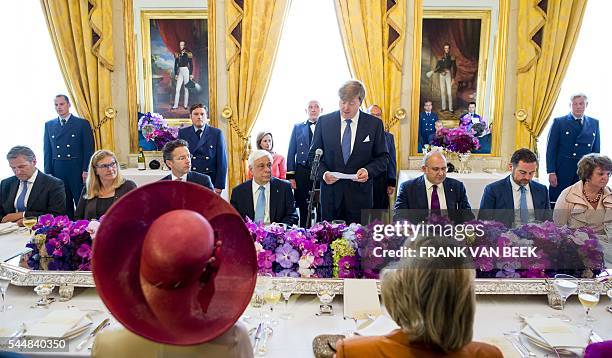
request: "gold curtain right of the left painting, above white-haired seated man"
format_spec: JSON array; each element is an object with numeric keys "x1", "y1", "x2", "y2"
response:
[{"x1": 223, "y1": 0, "x2": 291, "y2": 189}]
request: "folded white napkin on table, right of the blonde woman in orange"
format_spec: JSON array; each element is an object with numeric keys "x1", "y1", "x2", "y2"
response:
[{"x1": 521, "y1": 315, "x2": 591, "y2": 349}]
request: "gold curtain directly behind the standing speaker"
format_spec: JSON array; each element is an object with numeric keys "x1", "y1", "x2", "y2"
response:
[{"x1": 336, "y1": 0, "x2": 407, "y2": 157}]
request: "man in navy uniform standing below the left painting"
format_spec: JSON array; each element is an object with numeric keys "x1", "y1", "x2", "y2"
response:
[{"x1": 178, "y1": 103, "x2": 227, "y2": 194}]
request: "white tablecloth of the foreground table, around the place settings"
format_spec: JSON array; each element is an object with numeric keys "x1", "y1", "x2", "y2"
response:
[{"x1": 0, "y1": 286, "x2": 612, "y2": 358}]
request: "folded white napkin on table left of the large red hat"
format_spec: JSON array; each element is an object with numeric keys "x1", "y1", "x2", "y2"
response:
[{"x1": 26, "y1": 309, "x2": 92, "y2": 338}]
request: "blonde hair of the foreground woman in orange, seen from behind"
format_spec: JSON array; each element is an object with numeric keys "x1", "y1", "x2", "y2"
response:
[{"x1": 381, "y1": 235, "x2": 476, "y2": 353}]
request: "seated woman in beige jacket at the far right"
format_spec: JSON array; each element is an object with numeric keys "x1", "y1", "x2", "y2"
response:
[{"x1": 553, "y1": 153, "x2": 612, "y2": 234}]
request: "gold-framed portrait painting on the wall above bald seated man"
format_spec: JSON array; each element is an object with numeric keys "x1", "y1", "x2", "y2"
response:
[{"x1": 410, "y1": 0, "x2": 509, "y2": 156}]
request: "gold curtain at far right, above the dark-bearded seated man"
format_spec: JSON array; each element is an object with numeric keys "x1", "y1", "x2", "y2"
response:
[{"x1": 516, "y1": 0, "x2": 587, "y2": 150}]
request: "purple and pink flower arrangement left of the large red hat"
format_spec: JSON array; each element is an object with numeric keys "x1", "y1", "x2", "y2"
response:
[{"x1": 26, "y1": 214, "x2": 92, "y2": 271}]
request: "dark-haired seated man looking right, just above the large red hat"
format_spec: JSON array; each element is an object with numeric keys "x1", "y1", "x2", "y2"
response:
[{"x1": 161, "y1": 139, "x2": 215, "y2": 190}]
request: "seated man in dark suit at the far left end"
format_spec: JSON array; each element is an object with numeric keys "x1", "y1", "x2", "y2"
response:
[{"x1": 0, "y1": 146, "x2": 66, "y2": 226}]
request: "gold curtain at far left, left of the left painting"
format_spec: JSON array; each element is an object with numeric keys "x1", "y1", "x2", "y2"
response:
[{"x1": 41, "y1": 0, "x2": 115, "y2": 150}]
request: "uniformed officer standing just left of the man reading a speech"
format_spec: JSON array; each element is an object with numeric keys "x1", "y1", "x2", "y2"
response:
[{"x1": 287, "y1": 100, "x2": 323, "y2": 227}]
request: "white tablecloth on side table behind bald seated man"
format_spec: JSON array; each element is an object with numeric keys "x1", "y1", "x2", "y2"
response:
[{"x1": 397, "y1": 170, "x2": 510, "y2": 209}]
